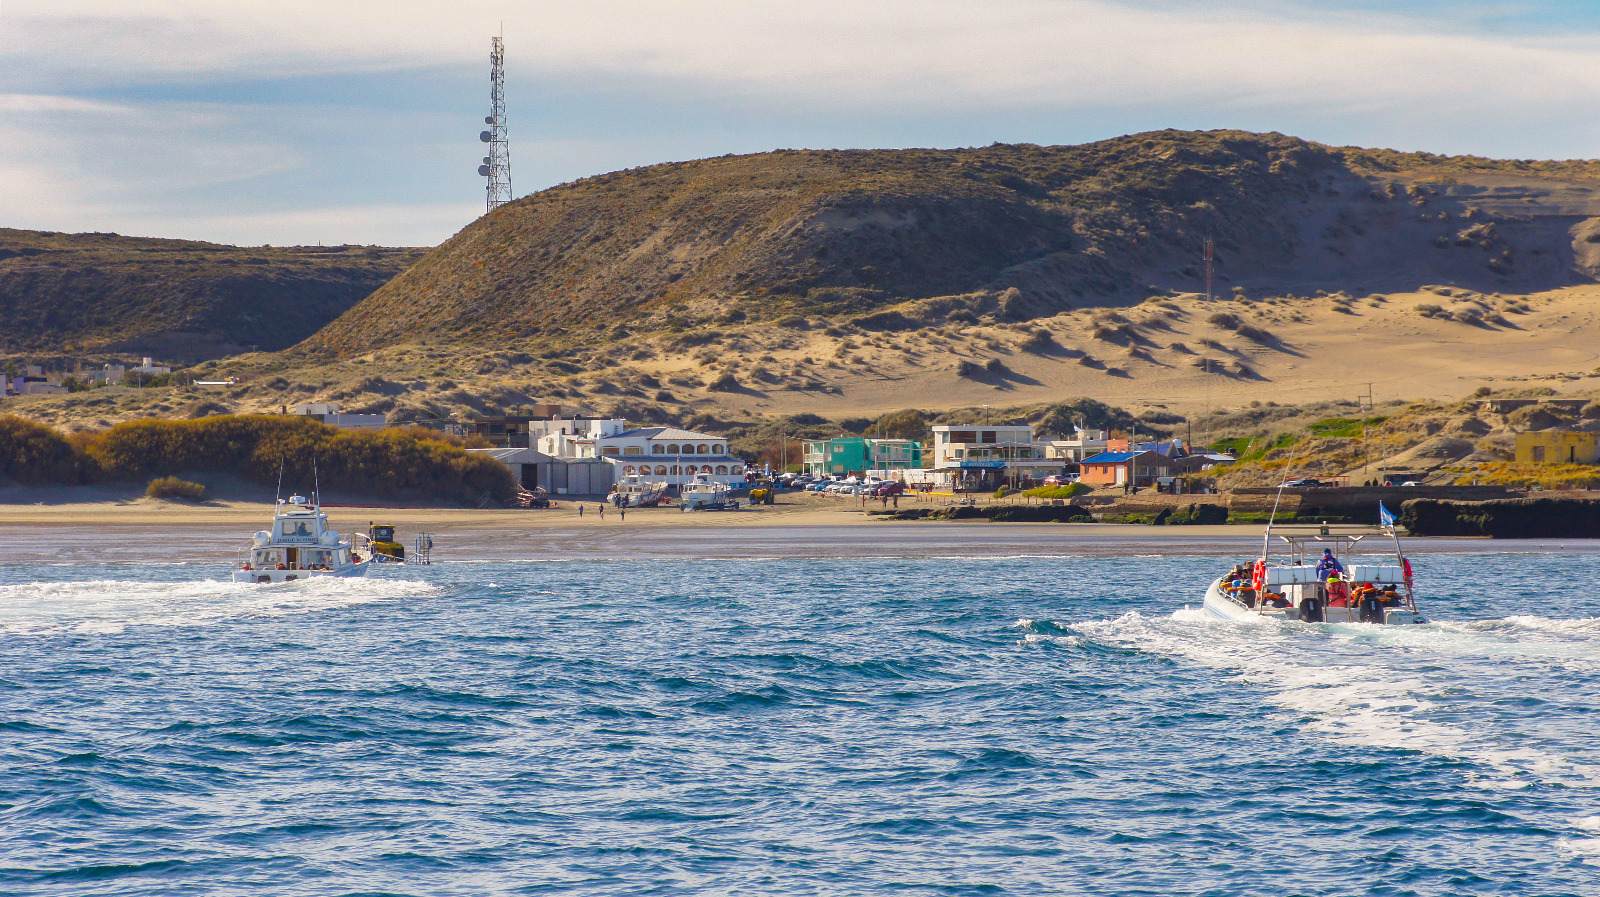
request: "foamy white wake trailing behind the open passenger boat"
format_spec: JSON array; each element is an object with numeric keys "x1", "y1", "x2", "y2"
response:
[{"x1": 1049, "y1": 608, "x2": 1600, "y2": 788}]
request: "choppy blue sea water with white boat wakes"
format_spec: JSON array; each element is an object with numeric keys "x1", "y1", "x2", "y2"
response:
[{"x1": 0, "y1": 529, "x2": 1600, "y2": 895}]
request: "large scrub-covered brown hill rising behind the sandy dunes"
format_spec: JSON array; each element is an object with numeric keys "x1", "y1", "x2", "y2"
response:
[{"x1": 302, "y1": 131, "x2": 1600, "y2": 352}]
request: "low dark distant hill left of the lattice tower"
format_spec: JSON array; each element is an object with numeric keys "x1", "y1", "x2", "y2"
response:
[{"x1": 0, "y1": 229, "x2": 422, "y2": 360}]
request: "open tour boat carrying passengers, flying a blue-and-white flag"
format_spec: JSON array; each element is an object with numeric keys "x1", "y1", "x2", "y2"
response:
[{"x1": 1205, "y1": 505, "x2": 1427, "y2": 624}]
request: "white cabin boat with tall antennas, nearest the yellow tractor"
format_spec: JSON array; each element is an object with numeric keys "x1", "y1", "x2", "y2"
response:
[{"x1": 234, "y1": 496, "x2": 373, "y2": 582}]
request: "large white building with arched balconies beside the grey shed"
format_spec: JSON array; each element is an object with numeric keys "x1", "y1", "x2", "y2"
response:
[{"x1": 539, "y1": 422, "x2": 744, "y2": 489}]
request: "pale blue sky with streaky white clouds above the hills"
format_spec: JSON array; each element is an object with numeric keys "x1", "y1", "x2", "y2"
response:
[{"x1": 9, "y1": 0, "x2": 1600, "y2": 246}]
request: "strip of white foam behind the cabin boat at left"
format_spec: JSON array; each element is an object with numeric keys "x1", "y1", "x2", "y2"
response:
[{"x1": 0, "y1": 577, "x2": 435, "y2": 635}]
